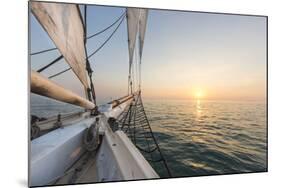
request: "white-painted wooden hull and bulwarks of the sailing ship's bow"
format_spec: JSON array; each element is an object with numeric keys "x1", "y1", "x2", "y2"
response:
[{"x1": 29, "y1": 100, "x2": 159, "y2": 186}]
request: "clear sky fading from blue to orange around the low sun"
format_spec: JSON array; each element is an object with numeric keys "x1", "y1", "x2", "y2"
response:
[{"x1": 30, "y1": 2, "x2": 266, "y2": 101}]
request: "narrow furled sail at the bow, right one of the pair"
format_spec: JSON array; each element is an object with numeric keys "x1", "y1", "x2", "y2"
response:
[{"x1": 139, "y1": 9, "x2": 148, "y2": 58}]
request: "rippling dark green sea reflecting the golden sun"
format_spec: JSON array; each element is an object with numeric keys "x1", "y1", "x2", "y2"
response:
[{"x1": 31, "y1": 96, "x2": 267, "y2": 177}]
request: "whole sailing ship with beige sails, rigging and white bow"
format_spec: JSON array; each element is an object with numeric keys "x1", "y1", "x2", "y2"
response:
[{"x1": 29, "y1": 1, "x2": 171, "y2": 186}]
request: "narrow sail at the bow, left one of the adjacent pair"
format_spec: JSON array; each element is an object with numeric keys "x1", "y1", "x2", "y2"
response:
[{"x1": 127, "y1": 8, "x2": 140, "y2": 70}]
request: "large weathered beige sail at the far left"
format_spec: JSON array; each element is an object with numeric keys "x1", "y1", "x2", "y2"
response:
[{"x1": 31, "y1": 1, "x2": 89, "y2": 88}]
